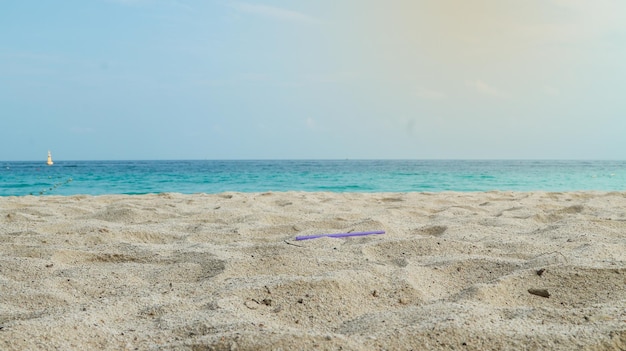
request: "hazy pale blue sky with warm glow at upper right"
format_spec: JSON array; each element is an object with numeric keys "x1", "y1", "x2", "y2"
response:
[{"x1": 0, "y1": 0, "x2": 626, "y2": 161}]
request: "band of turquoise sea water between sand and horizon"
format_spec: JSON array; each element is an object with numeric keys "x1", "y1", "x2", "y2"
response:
[{"x1": 0, "y1": 160, "x2": 626, "y2": 196}]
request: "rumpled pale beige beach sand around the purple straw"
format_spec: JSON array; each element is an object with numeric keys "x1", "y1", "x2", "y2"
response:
[{"x1": 0, "y1": 192, "x2": 626, "y2": 350}]
